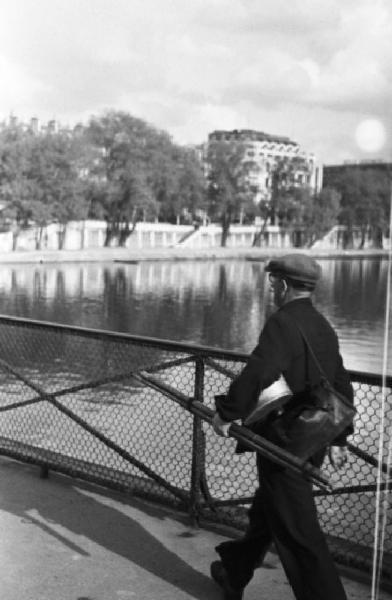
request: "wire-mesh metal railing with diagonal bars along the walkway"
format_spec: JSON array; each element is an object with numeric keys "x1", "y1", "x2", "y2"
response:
[{"x1": 0, "y1": 316, "x2": 392, "y2": 581}]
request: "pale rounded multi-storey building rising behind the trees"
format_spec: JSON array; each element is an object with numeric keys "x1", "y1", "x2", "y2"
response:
[{"x1": 208, "y1": 129, "x2": 319, "y2": 204}]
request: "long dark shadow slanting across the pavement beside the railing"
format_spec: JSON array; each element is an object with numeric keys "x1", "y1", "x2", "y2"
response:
[{"x1": 0, "y1": 460, "x2": 218, "y2": 600}]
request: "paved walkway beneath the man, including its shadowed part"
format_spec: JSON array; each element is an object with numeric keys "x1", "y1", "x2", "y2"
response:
[{"x1": 0, "y1": 457, "x2": 392, "y2": 600}]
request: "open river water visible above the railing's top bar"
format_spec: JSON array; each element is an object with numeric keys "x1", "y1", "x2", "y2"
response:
[{"x1": 0, "y1": 259, "x2": 392, "y2": 374}]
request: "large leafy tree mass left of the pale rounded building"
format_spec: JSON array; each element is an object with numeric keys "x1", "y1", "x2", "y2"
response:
[{"x1": 0, "y1": 111, "x2": 205, "y2": 248}]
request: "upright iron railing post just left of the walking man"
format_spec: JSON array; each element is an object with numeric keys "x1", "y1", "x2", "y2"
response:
[{"x1": 189, "y1": 356, "x2": 205, "y2": 525}]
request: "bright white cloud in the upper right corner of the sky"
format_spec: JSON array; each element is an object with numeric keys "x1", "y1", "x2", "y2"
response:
[{"x1": 219, "y1": 0, "x2": 392, "y2": 119}]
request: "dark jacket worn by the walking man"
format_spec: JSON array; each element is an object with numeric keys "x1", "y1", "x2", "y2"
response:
[{"x1": 216, "y1": 298, "x2": 354, "y2": 444}]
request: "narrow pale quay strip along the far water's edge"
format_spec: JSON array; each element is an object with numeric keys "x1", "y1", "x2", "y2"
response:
[{"x1": 0, "y1": 246, "x2": 388, "y2": 264}]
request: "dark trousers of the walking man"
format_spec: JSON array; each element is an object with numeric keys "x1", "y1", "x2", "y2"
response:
[{"x1": 216, "y1": 456, "x2": 347, "y2": 600}]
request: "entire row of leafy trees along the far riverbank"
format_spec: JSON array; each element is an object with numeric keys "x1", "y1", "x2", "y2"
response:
[{"x1": 0, "y1": 111, "x2": 389, "y2": 249}]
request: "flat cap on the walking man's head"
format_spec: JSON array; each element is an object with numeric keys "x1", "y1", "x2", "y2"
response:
[{"x1": 265, "y1": 254, "x2": 321, "y2": 284}]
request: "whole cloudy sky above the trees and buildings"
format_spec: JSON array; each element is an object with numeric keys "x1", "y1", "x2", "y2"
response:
[{"x1": 0, "y1": 0, "x2": 392, "y2": 164}]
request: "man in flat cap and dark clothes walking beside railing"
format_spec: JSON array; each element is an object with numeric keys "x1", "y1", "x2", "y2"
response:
[{"x1": 211, "y1": 254, "x2": 353, "y2": 600}]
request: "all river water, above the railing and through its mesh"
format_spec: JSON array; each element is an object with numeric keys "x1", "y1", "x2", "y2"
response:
[{"x1": 0, "y1": 259, "x2": 392, "y2": 551}]
